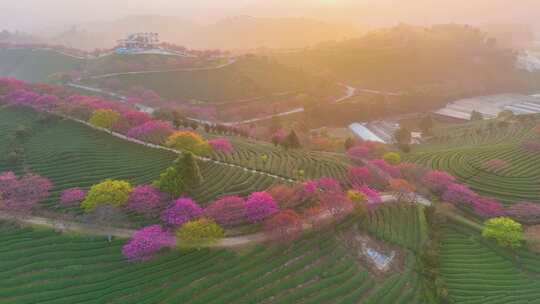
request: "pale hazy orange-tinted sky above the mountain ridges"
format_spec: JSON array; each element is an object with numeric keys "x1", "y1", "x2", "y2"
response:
[{"x1": 0, "y1": 0, "x2": 540, "y2": 30}]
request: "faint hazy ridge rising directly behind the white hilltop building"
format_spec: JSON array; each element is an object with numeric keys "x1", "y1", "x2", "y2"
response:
[{"x1": 51, "y1": 15, "x2": 358, "y2": 49}]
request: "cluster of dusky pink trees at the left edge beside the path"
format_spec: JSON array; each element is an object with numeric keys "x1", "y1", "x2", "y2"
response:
[{"x1": 0, "y1": 172, "x2": 53, "y2": 213}]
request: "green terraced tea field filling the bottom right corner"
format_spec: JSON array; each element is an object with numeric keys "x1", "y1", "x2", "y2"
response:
[{"x1": 440, "y1": 226, "x2": 540, "y2": 304}]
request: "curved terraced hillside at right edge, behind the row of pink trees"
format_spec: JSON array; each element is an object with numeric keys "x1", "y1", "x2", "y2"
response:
[{"x1": 406, "y1": 121, "x2": 540, "y2": 204}]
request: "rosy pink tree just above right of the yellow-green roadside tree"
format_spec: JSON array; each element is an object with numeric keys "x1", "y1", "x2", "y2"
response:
[{"x1": 204, "y1": 196, "x2": 247, "y2": 227}]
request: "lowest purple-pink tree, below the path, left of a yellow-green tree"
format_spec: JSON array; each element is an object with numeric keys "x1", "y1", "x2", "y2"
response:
[{"x1": 122, "y1": 225, "x2": 176, "y2": 262}]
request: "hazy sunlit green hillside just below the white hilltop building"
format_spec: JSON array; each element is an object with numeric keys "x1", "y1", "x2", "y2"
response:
[{"x1": 82, "y1": 58, "x2": 336, "y2": 102}]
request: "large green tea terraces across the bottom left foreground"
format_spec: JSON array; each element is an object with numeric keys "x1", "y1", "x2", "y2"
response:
[{"x1": 0, "y1": 223, "x2": 422, "y2": 304}]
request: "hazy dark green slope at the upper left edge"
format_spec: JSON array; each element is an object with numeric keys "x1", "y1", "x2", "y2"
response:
[{"x1": 0, "y1": 49, "x2": 84, "y2": 82}]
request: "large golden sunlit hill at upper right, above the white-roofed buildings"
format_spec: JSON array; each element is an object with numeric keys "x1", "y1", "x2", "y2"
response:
[{"x1": 275, "y1": 24, "x2": 536, "y2": 92}]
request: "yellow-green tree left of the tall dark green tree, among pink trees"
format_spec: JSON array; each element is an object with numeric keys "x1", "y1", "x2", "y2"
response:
[{"x1": 81, "y1": 179, "x2": 132, "y2": 212}]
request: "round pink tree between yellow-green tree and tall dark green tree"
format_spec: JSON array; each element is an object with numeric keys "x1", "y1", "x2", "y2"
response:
[{"x1": 126, "y1": 185, "x2": 167, "y2": 217}]
